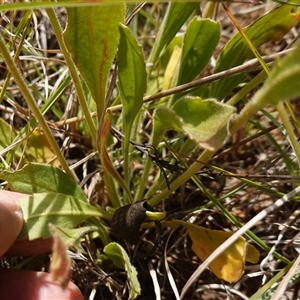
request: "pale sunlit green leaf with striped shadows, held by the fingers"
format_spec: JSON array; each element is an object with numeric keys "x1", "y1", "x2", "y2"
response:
[{"x1": 18, "y1": 193, "x2": 102, "y2": 240}]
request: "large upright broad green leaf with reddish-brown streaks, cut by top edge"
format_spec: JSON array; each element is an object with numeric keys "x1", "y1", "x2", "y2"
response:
[{"x1": 64, "y1": 4, "x2": 124, "y2": 117}]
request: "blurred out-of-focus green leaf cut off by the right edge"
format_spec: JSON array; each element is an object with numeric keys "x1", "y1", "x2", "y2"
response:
[{"x1": 252, "y1": 43, "x2": 300, "y2": 107}]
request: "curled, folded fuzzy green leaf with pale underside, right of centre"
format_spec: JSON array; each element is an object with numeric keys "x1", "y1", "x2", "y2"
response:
[{"x1": 151, "y1": 96, "x2": 235, "y2": 150}]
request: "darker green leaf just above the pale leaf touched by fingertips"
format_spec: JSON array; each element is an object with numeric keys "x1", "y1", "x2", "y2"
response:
[{"x1": 0, "y1": 163, "x2": 86, "y2": 201}]
